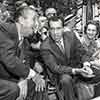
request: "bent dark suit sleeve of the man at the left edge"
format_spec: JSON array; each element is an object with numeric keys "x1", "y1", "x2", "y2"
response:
[{"x1": 0, "y1": 31, "x2": 30, "y2": 78}]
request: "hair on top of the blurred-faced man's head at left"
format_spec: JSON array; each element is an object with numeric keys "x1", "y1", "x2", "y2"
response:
[{"x1": 14, "y1": 6, "x2": 35, "y2": 22}]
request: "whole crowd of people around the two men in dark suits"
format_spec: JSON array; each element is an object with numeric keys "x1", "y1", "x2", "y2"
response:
[{"x1": 0, "y1": 1, "x2": 100, "y2": 100}]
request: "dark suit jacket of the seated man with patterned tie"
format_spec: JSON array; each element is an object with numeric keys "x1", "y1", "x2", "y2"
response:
[{"x1": 41, "y1": 32, "x2": 85, "y2": 81}]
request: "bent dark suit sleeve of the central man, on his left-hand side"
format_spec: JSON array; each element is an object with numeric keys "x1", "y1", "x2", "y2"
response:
[{"x1": 41, "y1": 45, "x2": 72, "y2": 74}]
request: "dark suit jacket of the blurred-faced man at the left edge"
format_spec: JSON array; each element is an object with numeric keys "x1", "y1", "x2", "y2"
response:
[{"x1": 0, "y1": 24, "x2": 29, "y2": 80}]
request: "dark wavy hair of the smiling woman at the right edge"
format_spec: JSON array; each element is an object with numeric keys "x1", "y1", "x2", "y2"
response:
[{"x1": 84, "y1": 20, "x2": 100, "y2": 36}]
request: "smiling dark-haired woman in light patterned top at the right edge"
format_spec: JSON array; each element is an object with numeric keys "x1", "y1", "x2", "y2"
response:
[{"x1": 80, "y1": 20, "x2": 100, "y2": 74}]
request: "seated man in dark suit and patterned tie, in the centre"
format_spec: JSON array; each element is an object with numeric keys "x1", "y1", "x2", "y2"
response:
[{"x1": 41, "y1": 17, "x2": 85, "y2": 100}]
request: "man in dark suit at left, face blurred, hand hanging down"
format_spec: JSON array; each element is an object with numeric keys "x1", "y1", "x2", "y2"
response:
[{"x1": 0, "y1": 7, "x2": 45, "y2": 100}]
